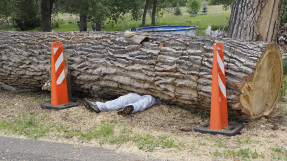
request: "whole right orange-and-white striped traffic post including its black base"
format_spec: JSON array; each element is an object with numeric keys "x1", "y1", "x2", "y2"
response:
[{"x1": 194, "y1": 43, "x2": 243, "y2": 136}]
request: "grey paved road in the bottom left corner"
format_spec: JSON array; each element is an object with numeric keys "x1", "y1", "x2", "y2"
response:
[{"x1": 0, "y1": 136, "x2": 160, "y2": 161}]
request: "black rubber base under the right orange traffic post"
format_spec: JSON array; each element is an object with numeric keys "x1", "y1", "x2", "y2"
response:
[{"x1": 194, "y1": 123, "x2": 244, "y2": 136}]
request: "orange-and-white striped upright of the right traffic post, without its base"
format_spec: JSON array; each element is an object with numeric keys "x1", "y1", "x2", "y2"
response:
[{"x1": 210, "y1": 43, "x2": 228, "y2": 130}]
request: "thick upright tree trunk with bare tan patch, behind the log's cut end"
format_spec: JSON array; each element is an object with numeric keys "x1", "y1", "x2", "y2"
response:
[{"x1": 228, "y1": 0, "x2": 283, "y2": 42}]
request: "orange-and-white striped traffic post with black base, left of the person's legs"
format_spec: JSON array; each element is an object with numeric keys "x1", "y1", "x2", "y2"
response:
[{"x1": 41, "y1": 42, "x2": 76, "y2": 109}]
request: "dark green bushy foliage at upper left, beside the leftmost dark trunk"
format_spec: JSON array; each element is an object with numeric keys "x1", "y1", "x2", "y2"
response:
[{"x1": 12, "y1": 0, "x2": 41, "y2": 31}]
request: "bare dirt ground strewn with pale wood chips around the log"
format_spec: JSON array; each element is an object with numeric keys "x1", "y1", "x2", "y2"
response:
[{"x1": 0, "y1": 90, "x2": 287, "y2": 160}]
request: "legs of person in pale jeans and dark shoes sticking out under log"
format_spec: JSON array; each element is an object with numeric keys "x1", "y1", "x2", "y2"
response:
[{"x1": 83, "y1": 93, "x2": 161, "y2": 115}]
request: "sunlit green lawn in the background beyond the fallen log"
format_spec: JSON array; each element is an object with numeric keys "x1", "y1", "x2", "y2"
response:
[{"x1": 2, "y1": 5, "x2": 230, "y2": 36}]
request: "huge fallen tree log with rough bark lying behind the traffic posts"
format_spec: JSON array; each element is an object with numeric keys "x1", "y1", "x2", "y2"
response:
[{"x1": 0, "y1": 31, "x2": 283, "y2": 118}]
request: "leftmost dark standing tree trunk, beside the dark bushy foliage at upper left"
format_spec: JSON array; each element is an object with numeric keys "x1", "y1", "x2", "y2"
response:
[{"x1": 41, "y1": 0, "x2": 54, "y2": 32}]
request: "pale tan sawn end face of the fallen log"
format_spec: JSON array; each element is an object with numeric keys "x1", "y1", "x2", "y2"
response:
[{"x1": 240, "y1": 44, "x2": 283, "y2": 119}]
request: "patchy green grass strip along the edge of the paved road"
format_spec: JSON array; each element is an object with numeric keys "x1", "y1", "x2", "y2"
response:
[{"x1": 0, "y1": 115, "x2": 185, "y2": 151}]
